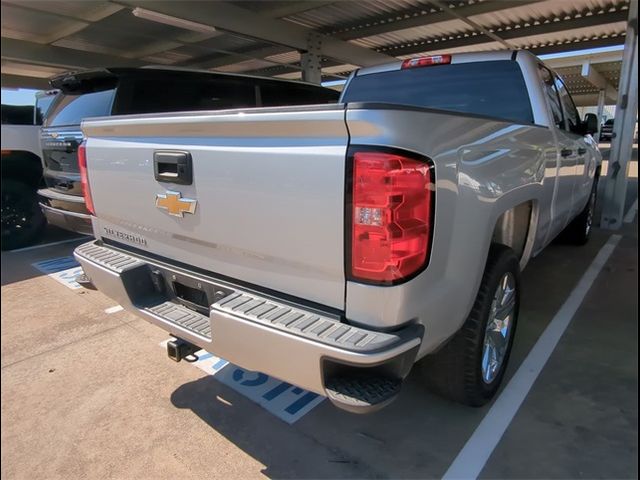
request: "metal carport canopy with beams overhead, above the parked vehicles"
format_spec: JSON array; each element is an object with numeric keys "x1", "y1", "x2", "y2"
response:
[{"x1": 1, "y1": 0, "x2": 637, "y2": 226}]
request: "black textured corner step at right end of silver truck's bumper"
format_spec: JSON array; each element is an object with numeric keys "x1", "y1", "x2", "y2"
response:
[{"x1": 325, "y1": 375, "x2": 402, "y2": 413}]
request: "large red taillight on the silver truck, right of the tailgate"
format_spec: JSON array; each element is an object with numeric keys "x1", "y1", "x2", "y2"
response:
[{"x1": 348, "y1": 150, "x2": 434, "y2": 285}]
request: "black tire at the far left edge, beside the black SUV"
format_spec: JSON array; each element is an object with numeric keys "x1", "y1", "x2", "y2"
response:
[{"x1": 0, "y1": 178, "x2": 46, "y2": 250}]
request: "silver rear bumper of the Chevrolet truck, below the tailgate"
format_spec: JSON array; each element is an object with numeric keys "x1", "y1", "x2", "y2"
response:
[{"x1": 74, "y1": 241, "x2": 423, "y2": 408}]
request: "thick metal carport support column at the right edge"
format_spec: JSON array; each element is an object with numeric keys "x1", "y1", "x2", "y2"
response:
[{"x1": 600, "y1": 2, "x2": 638, "y2": 230}]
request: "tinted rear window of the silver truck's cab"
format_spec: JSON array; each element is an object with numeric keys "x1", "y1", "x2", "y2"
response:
[{"x1": 342, "y1": 60, "x2": 533, "y2": 124}]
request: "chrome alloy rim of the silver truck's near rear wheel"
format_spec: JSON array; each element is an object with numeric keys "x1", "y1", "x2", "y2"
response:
[{"x1": 482, "y1": 272, "x2": 516, "y2": 384}]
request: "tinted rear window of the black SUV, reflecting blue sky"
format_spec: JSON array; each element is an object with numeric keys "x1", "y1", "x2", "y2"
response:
[{"x1": 45, "y1": 89, "x2": 115, "y2": 127}]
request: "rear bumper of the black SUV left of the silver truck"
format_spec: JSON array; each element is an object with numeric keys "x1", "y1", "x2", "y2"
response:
[{"x1": 38, "y1": 188, "x2": 93, "y2": 235}]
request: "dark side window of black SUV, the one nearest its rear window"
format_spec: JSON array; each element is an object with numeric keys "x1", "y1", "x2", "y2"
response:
[{"x1": 116, "y1": 78, "x2": 256, "y2": 114}]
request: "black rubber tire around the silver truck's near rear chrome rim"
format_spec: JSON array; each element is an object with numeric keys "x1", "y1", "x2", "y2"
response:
[{"x1": 419, "y1": 244, "x2": 520, "y2": 407}]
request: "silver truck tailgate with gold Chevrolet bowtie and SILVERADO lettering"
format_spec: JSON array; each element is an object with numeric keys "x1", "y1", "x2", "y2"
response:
[{"x1": 83, "y1": 105, "x2": 348, "y2": 309}]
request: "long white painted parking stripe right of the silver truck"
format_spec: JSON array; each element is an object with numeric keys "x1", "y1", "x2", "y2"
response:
[{"x1": 443, "y1": 235, "x2": 621, "y2": 479}]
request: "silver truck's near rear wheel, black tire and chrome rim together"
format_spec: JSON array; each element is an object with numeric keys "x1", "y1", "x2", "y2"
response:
[{"x1": 419, "y1": 244, "x2": 520, "y2": 407}]
